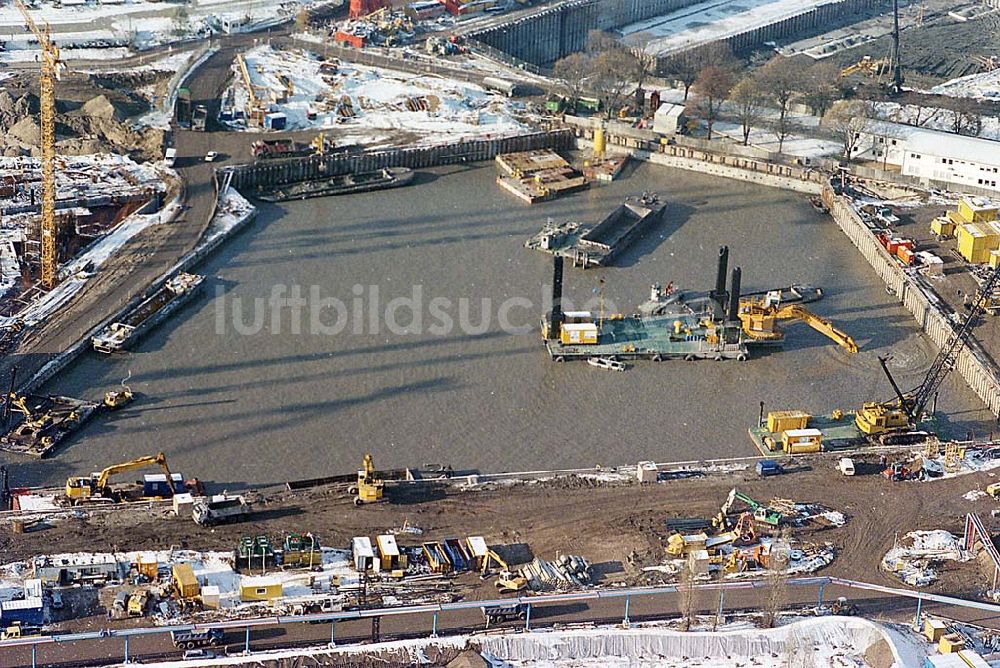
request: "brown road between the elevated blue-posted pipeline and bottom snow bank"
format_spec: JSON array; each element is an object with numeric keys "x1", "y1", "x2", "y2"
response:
[{"x1": 0, "y1": 580, "x2": 1000, "y2": 668}]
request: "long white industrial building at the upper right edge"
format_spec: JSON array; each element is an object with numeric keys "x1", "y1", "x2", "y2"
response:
[{"x1": 852, "y1": 122, "x2": 1000, "y2": 191}]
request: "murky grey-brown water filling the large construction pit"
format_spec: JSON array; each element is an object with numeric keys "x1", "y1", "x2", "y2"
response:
[{"x1": 14, "y1": 164, "x2": 990, "y2": 489}]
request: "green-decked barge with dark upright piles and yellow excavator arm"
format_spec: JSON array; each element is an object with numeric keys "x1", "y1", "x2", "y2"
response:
[{"x1": 542, "y1": 247, "x2": 857, "y2": 368}]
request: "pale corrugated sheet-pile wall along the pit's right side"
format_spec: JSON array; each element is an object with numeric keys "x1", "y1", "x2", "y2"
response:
[{"x1": 823, "y1": 189, "x2": 1000, "y2": 416}]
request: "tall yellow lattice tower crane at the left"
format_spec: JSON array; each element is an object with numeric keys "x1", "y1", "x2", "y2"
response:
[{"x1": 14, "y1": 0, "x2": 62, "y2": 290}]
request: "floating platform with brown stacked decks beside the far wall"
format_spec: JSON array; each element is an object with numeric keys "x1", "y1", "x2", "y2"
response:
[{"x1": 496, "y1": 150, "x2": 590, "y2": 204}]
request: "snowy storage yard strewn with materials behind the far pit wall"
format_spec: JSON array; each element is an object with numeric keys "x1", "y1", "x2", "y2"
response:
[{"x1": 234, "y1": 46, "x2": 526, "y2": 145}]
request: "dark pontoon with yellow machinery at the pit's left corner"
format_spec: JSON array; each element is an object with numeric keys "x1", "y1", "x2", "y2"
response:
[{"x1": 0, "y1": 395, "x2": 98, "y2": 458}]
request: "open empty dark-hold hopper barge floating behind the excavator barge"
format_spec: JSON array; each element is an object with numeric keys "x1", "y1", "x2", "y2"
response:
[{"x1": 524, "y1": 193, "x2": 667, "y2": 269}]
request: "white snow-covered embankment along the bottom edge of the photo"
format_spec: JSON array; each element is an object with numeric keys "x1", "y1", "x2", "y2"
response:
[{"x1": 125, "y1": 617, "x2": 933, "y2": 668}]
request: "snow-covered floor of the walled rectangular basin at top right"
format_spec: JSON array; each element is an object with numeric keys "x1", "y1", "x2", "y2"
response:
[{"x1": 621, "y1": 0, "x2": 834, "y2": 55}]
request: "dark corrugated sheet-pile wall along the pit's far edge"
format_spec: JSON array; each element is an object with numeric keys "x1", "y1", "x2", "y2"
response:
[{"x1": 229, "y1": 130, "x2": 575, "y2": 189}]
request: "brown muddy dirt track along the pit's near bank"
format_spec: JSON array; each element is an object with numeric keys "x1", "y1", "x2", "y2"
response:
[{"x1": 7, "y1": 457, "x2": 996, "y2": 597}]
